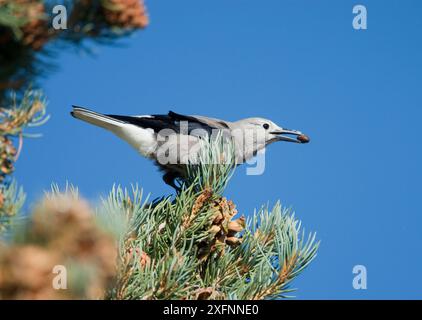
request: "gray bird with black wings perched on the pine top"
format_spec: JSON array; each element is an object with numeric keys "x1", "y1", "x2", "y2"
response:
[{"x1": 71, "y1": 106, "x2": 309, "y2": 189}]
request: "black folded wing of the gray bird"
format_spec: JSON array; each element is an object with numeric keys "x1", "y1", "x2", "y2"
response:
[{"x1": 106, "y1": 111, "x2": 217, "y2": 135}]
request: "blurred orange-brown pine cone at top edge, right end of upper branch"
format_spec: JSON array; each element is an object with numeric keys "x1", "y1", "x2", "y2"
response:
[{"x1": 103, "y1": 0, "x2": 149, "y2": 28}]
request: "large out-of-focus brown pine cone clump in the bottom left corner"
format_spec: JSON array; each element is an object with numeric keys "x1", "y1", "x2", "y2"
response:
[{"x1": 0, "y1": 196, "x2": 117, "y2": 299}]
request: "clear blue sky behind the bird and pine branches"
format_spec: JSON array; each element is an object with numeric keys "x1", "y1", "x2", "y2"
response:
[{"x1": 16, "y1": 0, "x2": 422, "y2": 299}]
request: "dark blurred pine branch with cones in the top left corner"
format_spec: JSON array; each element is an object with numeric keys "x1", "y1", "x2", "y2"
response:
[{"x1": 0, "y1": 0, "x2": 148, "y2": 99}]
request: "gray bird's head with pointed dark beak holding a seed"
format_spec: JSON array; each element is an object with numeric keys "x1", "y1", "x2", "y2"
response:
[{"x1": 236, "y1": 118, "x2": 310, "y2": 145}]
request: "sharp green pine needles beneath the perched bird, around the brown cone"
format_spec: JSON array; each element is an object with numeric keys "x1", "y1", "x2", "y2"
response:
[{"x1": 98, "y1": 136, "x2": 319, "y2": 299}]
